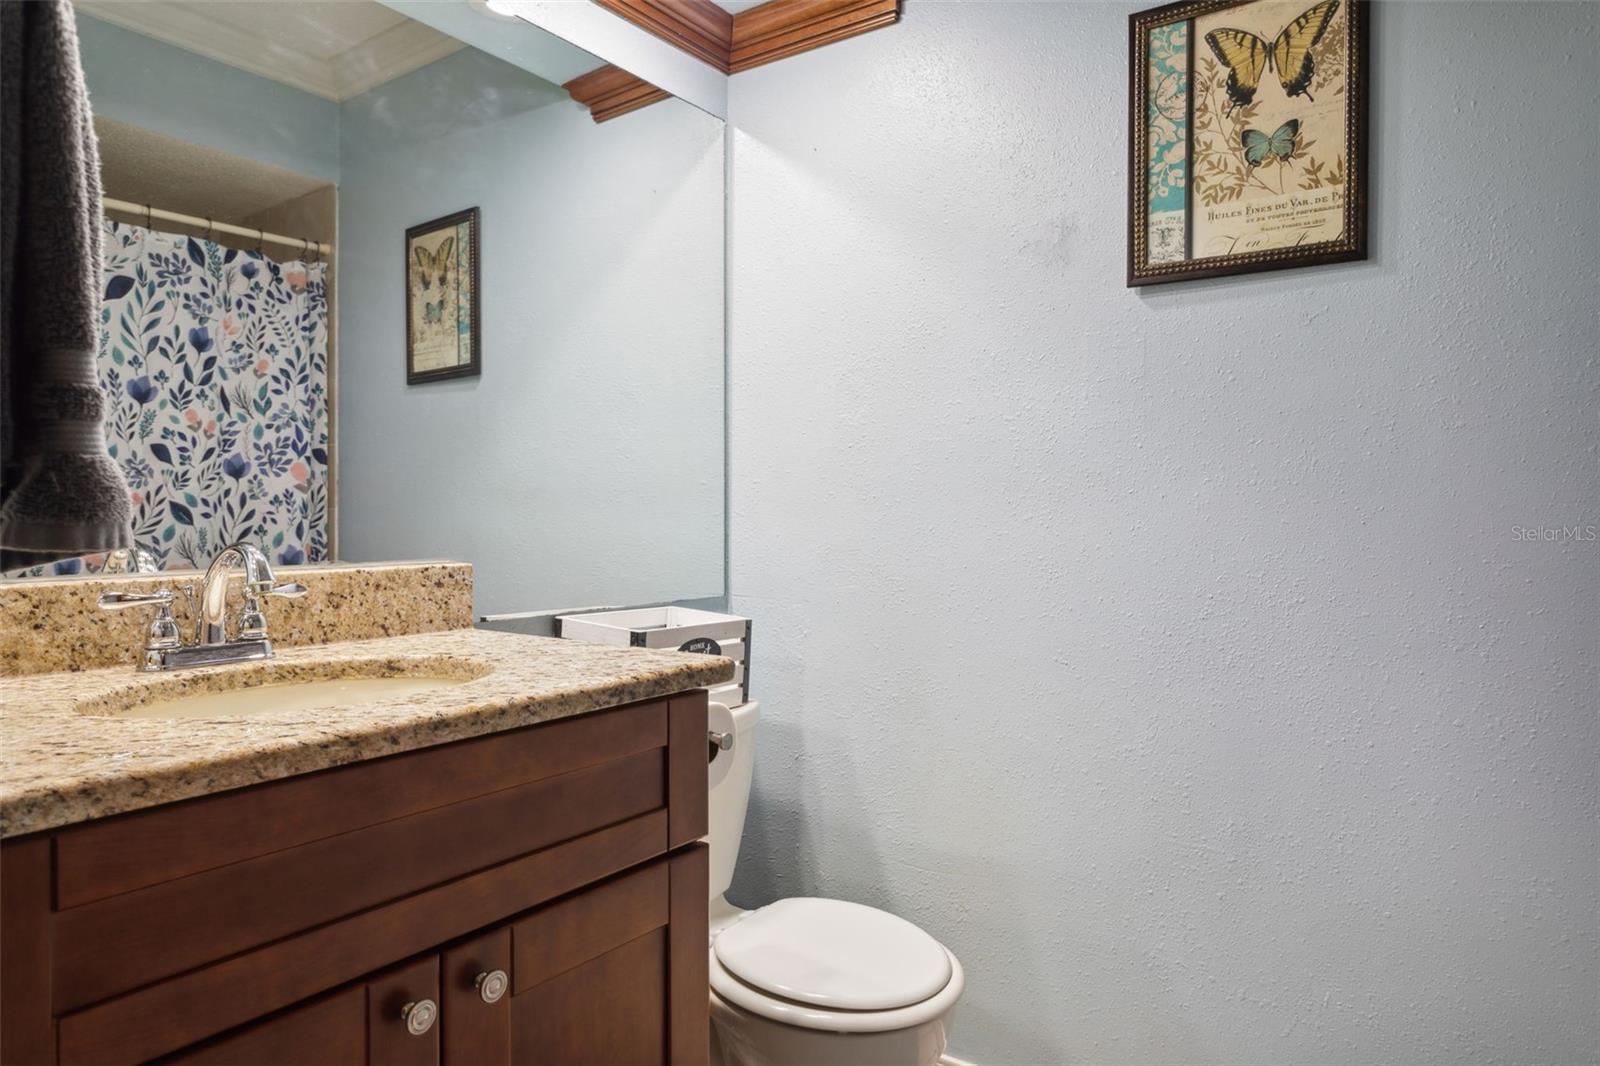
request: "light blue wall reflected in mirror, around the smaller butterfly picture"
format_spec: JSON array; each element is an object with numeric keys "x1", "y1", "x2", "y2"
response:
[{"x1": 338, "y1": 50, "x2": 723, "y2": 613}]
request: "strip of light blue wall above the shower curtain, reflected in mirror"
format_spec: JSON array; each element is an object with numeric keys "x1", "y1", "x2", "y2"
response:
[{"x1": 78, "y1": 13, "x2": 339, "y2": 182}]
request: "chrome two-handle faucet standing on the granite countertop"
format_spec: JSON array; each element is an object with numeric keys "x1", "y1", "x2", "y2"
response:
[{"x1": 99, "y1": 541, "x2": 306, "y2": 672}]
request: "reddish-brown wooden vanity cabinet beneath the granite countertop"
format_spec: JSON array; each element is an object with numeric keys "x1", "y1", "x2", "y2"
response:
[{"x1": 0, "y1": 691, "x2": 709, "y2": 1066}]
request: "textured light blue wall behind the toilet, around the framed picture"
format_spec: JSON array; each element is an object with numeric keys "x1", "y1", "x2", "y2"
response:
[{"x1": 730, "y1": 0, "x2": 1600, "y2": 1066}]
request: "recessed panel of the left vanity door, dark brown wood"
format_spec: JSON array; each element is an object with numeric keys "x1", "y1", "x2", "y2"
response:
[{"x1": 168, "y1": 984, "x2": 366, "y2": 1066}]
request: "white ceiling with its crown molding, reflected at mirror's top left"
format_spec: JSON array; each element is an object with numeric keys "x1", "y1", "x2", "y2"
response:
[{"x1": 75, "y1": 0, "x2": 464, "y2": 101}]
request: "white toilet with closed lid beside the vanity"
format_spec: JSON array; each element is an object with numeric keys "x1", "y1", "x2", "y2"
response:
[{"x1": 707, "y1": 703, "x2": 965, "y2": 1066}]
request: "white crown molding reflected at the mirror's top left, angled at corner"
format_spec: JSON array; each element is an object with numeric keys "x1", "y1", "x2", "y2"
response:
[{"x1": 75, "y1": 0, "x2": 466, "y2": 102}]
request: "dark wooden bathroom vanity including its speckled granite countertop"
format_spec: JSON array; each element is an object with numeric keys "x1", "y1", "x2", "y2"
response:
[{"x1": 0, "y1": 592, "x2": 731, "y2": 1066}]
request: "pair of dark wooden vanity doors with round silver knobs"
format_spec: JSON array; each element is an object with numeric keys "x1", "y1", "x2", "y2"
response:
[{"x1": 162, "y1": 845, "x2": 706, "y2": 1066}]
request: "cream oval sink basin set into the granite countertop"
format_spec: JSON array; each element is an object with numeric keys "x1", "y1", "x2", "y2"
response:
[{"x1": 77, "y1": 656, "x2": 490, "y2": 719}]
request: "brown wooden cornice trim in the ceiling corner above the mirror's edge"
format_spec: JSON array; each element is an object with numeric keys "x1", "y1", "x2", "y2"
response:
[{"x1": 594, "y1": 0, "x2": 901, "y2": 74}]
